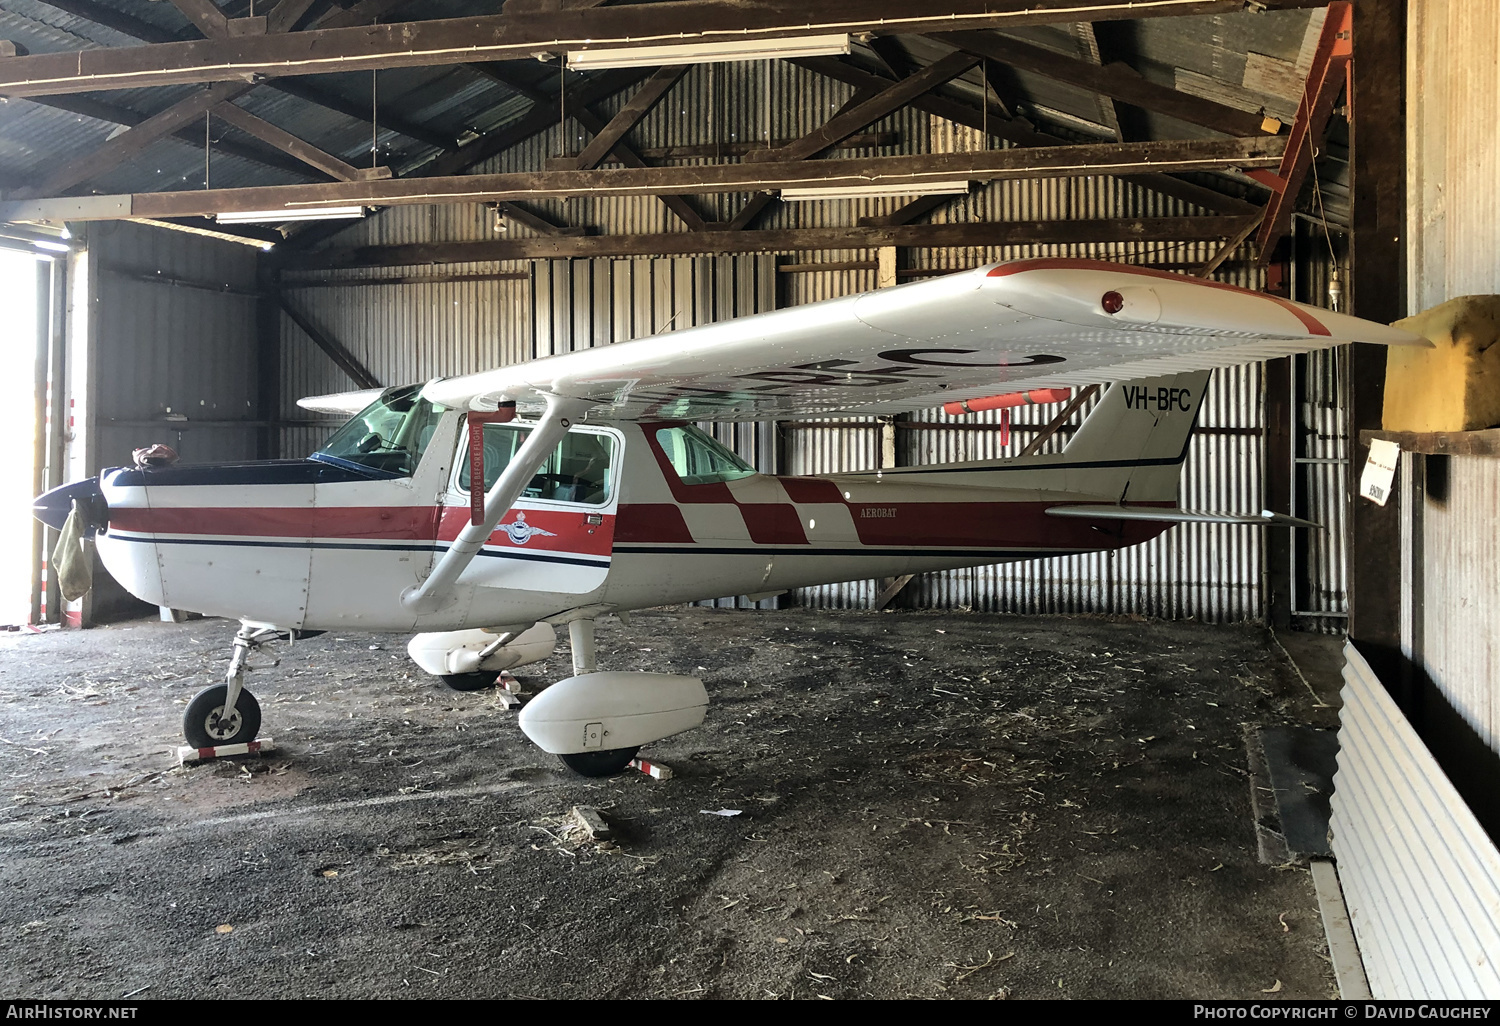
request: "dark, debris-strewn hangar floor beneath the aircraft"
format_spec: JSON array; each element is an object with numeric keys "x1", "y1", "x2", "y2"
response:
[{"x1": 0, "y1": 609, "x2": 1337, "y2": 999}]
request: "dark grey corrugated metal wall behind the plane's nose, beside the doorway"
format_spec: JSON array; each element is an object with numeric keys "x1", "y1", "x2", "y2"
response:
[{"x1": 87, "y1": 222, "x2": 260, "y2": 470}]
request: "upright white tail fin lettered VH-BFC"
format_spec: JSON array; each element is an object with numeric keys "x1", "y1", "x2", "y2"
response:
[{"x1": 1062, "y1": 371, "x2": 1209, "y2": 503}]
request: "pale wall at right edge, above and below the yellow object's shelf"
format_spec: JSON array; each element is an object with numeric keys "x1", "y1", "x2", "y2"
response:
[{"x1": 1404, "y1": 0, "x2": 1500, "y2": 753}]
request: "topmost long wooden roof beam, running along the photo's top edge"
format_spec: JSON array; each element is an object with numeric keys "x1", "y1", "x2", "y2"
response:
[{"x1": 0, "y1": 0, "x2": 1326, "y2": 96}]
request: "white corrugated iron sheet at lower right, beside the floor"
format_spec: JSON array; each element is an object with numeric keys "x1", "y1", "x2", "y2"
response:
[{"x1": 1332, "y1": 645, "x2": 1500, "y2": 1001}]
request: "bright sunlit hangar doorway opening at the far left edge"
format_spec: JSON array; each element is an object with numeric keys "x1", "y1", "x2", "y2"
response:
[{"x1": 0, "y1": 251, "x2": 48, "y2": 626}]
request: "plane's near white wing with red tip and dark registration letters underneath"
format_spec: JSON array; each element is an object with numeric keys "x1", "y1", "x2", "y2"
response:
[{"x1": 426, "y1": 260, "x2": 1431, "y2": 422}]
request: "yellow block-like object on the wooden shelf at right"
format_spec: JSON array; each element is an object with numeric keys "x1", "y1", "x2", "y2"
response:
[{"x1": 1382, "y1": 296, "x2": 1500, "y2": 432}]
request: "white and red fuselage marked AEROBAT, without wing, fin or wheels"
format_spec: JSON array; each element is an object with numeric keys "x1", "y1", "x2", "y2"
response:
[{"x1": 87, "y1": 411, "x2": 1167, "y2": 632}]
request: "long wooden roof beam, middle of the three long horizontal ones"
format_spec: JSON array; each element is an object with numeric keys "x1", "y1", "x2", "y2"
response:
[{"x1": 0, "y1": 136, "x2": 1284, "y2": 227}]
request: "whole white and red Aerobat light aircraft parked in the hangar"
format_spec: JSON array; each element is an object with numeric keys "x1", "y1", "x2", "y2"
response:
[{"x1": 29, "y1": 260, "x2": 1428, "y2": 776}]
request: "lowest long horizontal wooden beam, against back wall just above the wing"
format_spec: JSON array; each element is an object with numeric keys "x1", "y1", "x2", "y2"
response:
[{"x1": 284, "y1": 218, "x2": 1244, "y2": 269}]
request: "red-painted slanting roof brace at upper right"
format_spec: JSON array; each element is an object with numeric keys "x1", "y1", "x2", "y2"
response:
[{"x1": 1256, "y1": 0, "x2": 1355, "y2": 263}]
